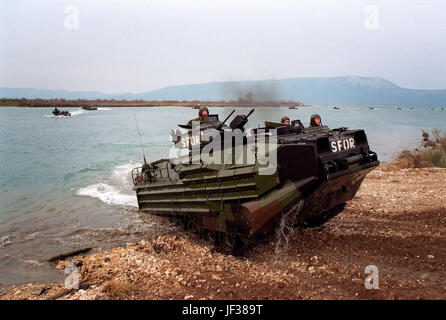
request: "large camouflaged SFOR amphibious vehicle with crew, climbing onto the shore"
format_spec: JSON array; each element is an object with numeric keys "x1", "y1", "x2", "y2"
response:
[{"x1": 132, "y1": 108, "x2": 379, "y2": 252}]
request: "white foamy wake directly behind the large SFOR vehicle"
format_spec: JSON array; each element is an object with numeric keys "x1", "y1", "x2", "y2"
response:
[{"x1": 76, "y1": 162, "x2": 138, "y2": 208}]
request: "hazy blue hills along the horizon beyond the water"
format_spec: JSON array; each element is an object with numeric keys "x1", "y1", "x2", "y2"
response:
[{"x1": 0, "y1": 76, "x2": 446, "y2": 107}]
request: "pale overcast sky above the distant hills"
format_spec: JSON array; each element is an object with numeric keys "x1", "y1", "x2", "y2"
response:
[{"x1": 0, "y1": 0, "x2": 446, "y2": 93}]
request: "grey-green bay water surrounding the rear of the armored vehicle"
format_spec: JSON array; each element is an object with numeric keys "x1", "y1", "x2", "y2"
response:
[{"x1": 0, "y1": 107, "x2": 446, "y2": 286}]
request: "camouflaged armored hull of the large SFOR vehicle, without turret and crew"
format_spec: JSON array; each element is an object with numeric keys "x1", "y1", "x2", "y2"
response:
[{"x1": 132, "y1": 114, "x2": 379, "y2": 251}]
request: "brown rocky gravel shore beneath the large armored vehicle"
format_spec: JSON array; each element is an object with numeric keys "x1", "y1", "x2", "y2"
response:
[{"x1": 0, "y1": 163, "x2": 446, "y2": 300}]
